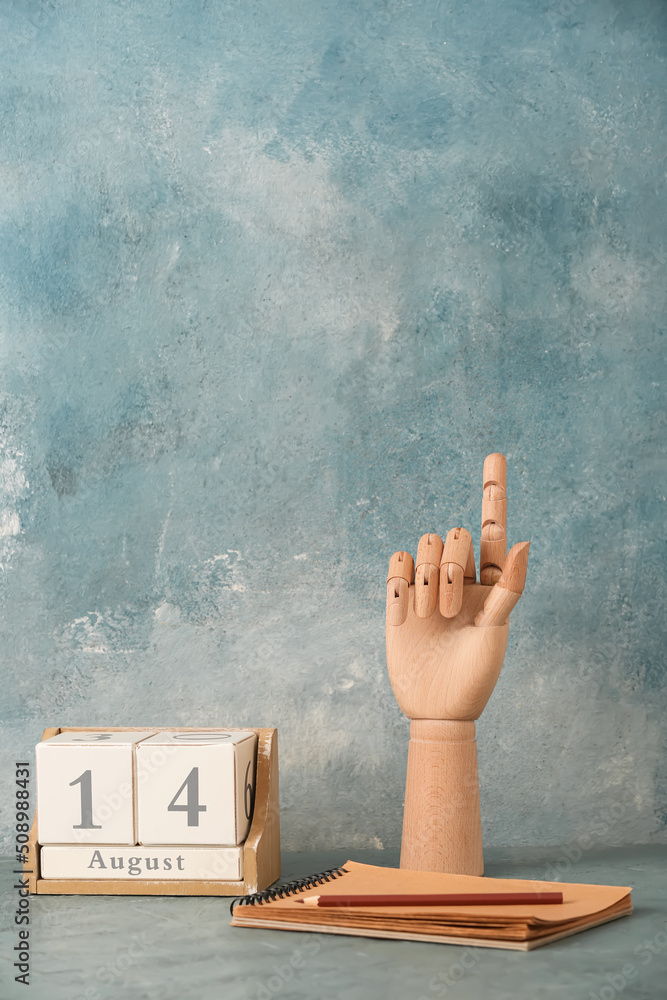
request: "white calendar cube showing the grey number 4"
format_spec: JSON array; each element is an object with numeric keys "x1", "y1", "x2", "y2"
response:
[{"x1": 136, "y1": 729, "x2": 257, "y2": 846}]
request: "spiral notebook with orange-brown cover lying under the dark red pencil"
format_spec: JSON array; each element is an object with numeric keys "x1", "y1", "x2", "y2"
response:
[{"x1": 231, "y1": 861, "x2": 632, "y2": 951}]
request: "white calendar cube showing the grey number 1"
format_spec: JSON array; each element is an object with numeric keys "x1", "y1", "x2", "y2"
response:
[{"x1": 36, "y1": 730, "x2": 157, "y2": 844}]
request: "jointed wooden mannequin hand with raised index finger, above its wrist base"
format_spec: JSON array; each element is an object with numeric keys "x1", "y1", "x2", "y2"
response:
[{"x1": 386, "y1": 454, "x2": 529, "y2": 721}]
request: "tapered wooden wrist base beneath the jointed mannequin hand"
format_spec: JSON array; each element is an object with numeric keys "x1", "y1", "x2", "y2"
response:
[{"x1": 401, "y1": 719, "x2": 484, "y2": 875}]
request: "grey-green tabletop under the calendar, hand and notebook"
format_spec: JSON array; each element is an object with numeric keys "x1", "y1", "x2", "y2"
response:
[{"x1": 0, "y1": 846, "x2": 667, "y2": 1000}]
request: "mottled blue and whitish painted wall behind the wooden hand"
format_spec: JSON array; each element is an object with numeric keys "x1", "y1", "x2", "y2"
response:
[{"x1": 0, "y1": 0, "x2": 667, "y2": 850}]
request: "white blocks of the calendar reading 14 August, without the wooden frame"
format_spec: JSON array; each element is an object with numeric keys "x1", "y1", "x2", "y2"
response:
[{"x1": 36, "y1": 730, "x2": 258, "y2": 881}]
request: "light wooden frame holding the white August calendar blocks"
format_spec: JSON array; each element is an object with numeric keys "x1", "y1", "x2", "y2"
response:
[{"x1": 24, "y1": 726, "x2": 280, "y2": 896}]
